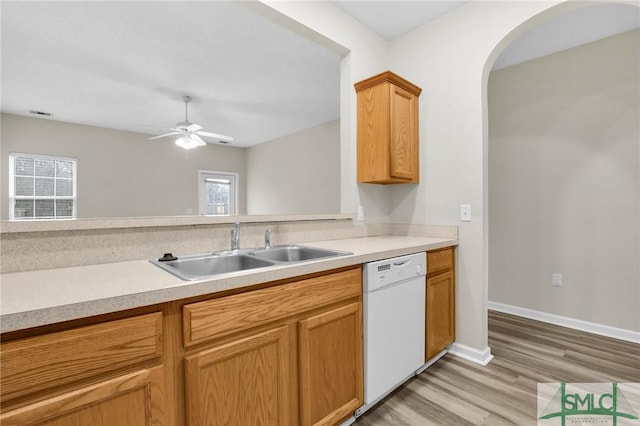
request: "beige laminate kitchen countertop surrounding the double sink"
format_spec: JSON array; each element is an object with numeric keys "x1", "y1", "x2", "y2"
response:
[{"x1": 0, "y1": 236, "x2": 458, "y2": 333}]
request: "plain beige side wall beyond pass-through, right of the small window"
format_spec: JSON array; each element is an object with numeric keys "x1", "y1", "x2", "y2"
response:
[{"x1": 247, "y1": 120, "x2": 340, "y2": 214}]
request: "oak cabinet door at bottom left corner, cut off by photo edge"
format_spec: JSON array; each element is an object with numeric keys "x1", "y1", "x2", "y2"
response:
[{"x1": 0, "y1": 367, "x2": 166, "y2": 426}]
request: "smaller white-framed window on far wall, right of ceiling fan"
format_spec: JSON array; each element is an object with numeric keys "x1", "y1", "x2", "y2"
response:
[{"x1": 198, "y1": 170, "x2": 238, "y2": 216}]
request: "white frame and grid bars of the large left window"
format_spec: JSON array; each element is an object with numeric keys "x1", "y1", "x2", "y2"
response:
[{"x1": 8, "y1": 152, "x2": 78, "y2": 221}]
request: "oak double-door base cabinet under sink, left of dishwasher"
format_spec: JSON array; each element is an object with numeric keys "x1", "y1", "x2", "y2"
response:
[{"x1": 183, "y1": 266, "x2": 364, "y2": 426}]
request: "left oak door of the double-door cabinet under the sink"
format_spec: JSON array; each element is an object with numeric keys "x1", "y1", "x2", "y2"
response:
[{"x1": 185, "y1": 326, "x2": 291, "y2": 426}]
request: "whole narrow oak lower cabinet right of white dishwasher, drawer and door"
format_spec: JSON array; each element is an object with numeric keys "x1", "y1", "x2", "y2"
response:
[{"x1": 425, "y1": 247, "x2": 456, "y2": 361}]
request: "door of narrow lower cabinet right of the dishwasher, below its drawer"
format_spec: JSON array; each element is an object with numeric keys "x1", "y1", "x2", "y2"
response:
[{"x1": 426, "y1": 271, "x2": 455, "y2": 360}]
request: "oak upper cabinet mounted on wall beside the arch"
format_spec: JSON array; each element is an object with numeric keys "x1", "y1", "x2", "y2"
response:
[{"x1": 355, "y1": 71, "x2": 422, "y2": 184}]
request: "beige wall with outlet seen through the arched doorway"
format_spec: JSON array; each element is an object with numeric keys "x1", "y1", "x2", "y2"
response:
[{"x1": 488, "y1": 30, "x2": 640, "y2": 331}]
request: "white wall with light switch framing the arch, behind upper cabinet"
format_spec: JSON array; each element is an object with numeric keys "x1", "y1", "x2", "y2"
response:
[{"x1": 384, "y1": 1, "x2": 592, "y2": 356}]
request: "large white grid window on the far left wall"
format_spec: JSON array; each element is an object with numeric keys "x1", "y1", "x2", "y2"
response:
[{"x1": 9, "y1": 153, "x2": 78, "y2": 220}]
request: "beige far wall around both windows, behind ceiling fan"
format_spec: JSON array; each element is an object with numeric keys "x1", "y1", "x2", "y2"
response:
[{"x1": 0, "y1": 114, "x2": 246, "y2": 219}]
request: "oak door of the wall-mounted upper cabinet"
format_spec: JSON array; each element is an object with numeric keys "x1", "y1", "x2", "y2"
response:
[{"x1": 389, "y1": 84, "x2": 418, "y2": 181}]
